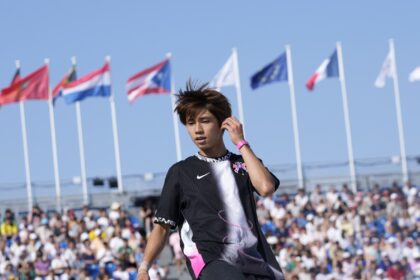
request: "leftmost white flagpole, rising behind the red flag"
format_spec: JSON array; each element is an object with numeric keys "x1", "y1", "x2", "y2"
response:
[{"x1": 16, "y1": 60, "x2": 33, "y2": 212}]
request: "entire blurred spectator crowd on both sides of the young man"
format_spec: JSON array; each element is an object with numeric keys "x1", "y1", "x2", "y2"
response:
[{"x1": 0, "y1": 180, "x2": 420, "y2": 280}]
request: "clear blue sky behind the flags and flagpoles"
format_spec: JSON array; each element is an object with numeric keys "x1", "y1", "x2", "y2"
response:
[{"x1": 0, "y1": 0, "x2": 420, "y2": 188}]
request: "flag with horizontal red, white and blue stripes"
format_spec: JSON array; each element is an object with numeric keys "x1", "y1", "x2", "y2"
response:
[{"x1": 61, "y1": 63, "x2": 111, "y2": 104}]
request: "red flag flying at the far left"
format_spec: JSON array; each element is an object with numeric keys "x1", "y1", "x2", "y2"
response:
[{"x1": 0, "y1": 65, "x2": 49, "y2": 105}]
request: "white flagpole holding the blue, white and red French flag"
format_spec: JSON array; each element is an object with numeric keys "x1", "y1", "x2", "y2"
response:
[{"x1": 337, "y1": 42, "x2": 357, "y2": 192}]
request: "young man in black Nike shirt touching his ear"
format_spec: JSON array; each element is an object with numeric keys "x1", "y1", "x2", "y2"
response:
[{"x1": 137, "y1": 83, "x2": 284, "y2": 280}]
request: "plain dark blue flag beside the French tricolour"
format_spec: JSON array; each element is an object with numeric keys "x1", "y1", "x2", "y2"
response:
[{"x1": 251, "y1": 53, "x2": 288, "y2": 89}]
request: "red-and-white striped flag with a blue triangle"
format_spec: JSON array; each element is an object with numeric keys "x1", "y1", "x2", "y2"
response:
[{"x1": 125, "y1": 59, "x2": 171, "y2": 103}]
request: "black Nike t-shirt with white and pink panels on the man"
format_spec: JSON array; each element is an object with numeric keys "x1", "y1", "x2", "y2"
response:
[{"x1": 154, "y1": 152, "x2": 284, "y2": 279}]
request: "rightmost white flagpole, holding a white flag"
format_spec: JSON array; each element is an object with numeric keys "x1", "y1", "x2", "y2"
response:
[{"x1": 389, "y1": 39, "x2": 408, "y2": 184}]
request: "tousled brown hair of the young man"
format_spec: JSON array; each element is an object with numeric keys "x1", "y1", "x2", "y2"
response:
[{"x1": 175, "y1": 80, "x2": 232, "y2": 125}]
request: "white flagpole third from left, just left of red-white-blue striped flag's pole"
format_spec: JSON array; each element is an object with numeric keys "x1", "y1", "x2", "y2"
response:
[{"x1": 71, "y1": 56, "x2": 89, "y2": 205}]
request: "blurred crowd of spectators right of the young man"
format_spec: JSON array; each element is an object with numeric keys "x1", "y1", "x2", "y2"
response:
[{"x1": 257, "y1": 184, "x2": 420, "y2": 280}]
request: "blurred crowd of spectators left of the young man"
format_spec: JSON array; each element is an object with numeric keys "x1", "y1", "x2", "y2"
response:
[{"x1": 0, "y1": 200, "x2": 166, "y2": 280}]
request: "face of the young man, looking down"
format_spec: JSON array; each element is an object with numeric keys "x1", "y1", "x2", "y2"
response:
[{"x1": 186, "y1": 109, "x2": 223, "y2": 151}]
